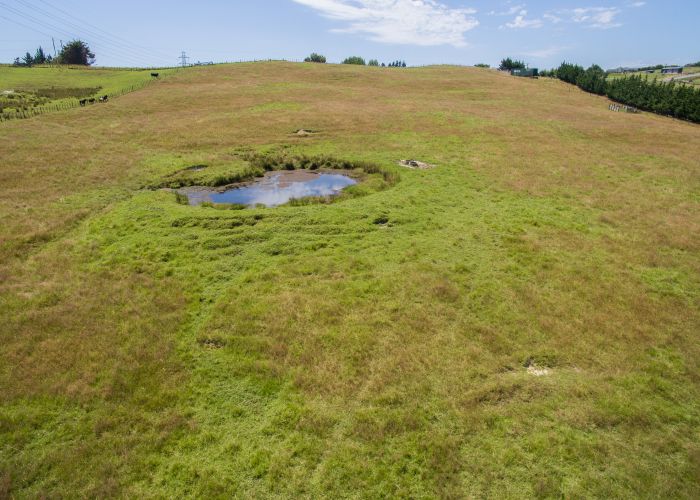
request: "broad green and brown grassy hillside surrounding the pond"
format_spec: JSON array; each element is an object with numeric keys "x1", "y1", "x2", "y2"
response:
[{"x1": 0, "y1": 63, "x2": 700, "y2": 498}]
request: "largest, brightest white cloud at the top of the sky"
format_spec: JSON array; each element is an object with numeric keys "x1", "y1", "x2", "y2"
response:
[{"x1": 293, "y1": 0, "x2": 479, "y2": 47}]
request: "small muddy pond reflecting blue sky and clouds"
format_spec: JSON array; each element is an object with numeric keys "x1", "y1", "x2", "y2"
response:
[{"x1": 179, "y1": 170, "x2": 357, "y2": 207}]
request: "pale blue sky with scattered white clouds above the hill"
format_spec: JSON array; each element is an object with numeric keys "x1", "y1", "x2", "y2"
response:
[{"x1": 0, "y1": 0, "x2": 700, "y2": 68}]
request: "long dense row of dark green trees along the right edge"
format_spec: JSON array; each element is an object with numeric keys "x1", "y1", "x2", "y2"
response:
[{"x1": 544, "y1": 62, "x2": 700, "y2": 123}]
